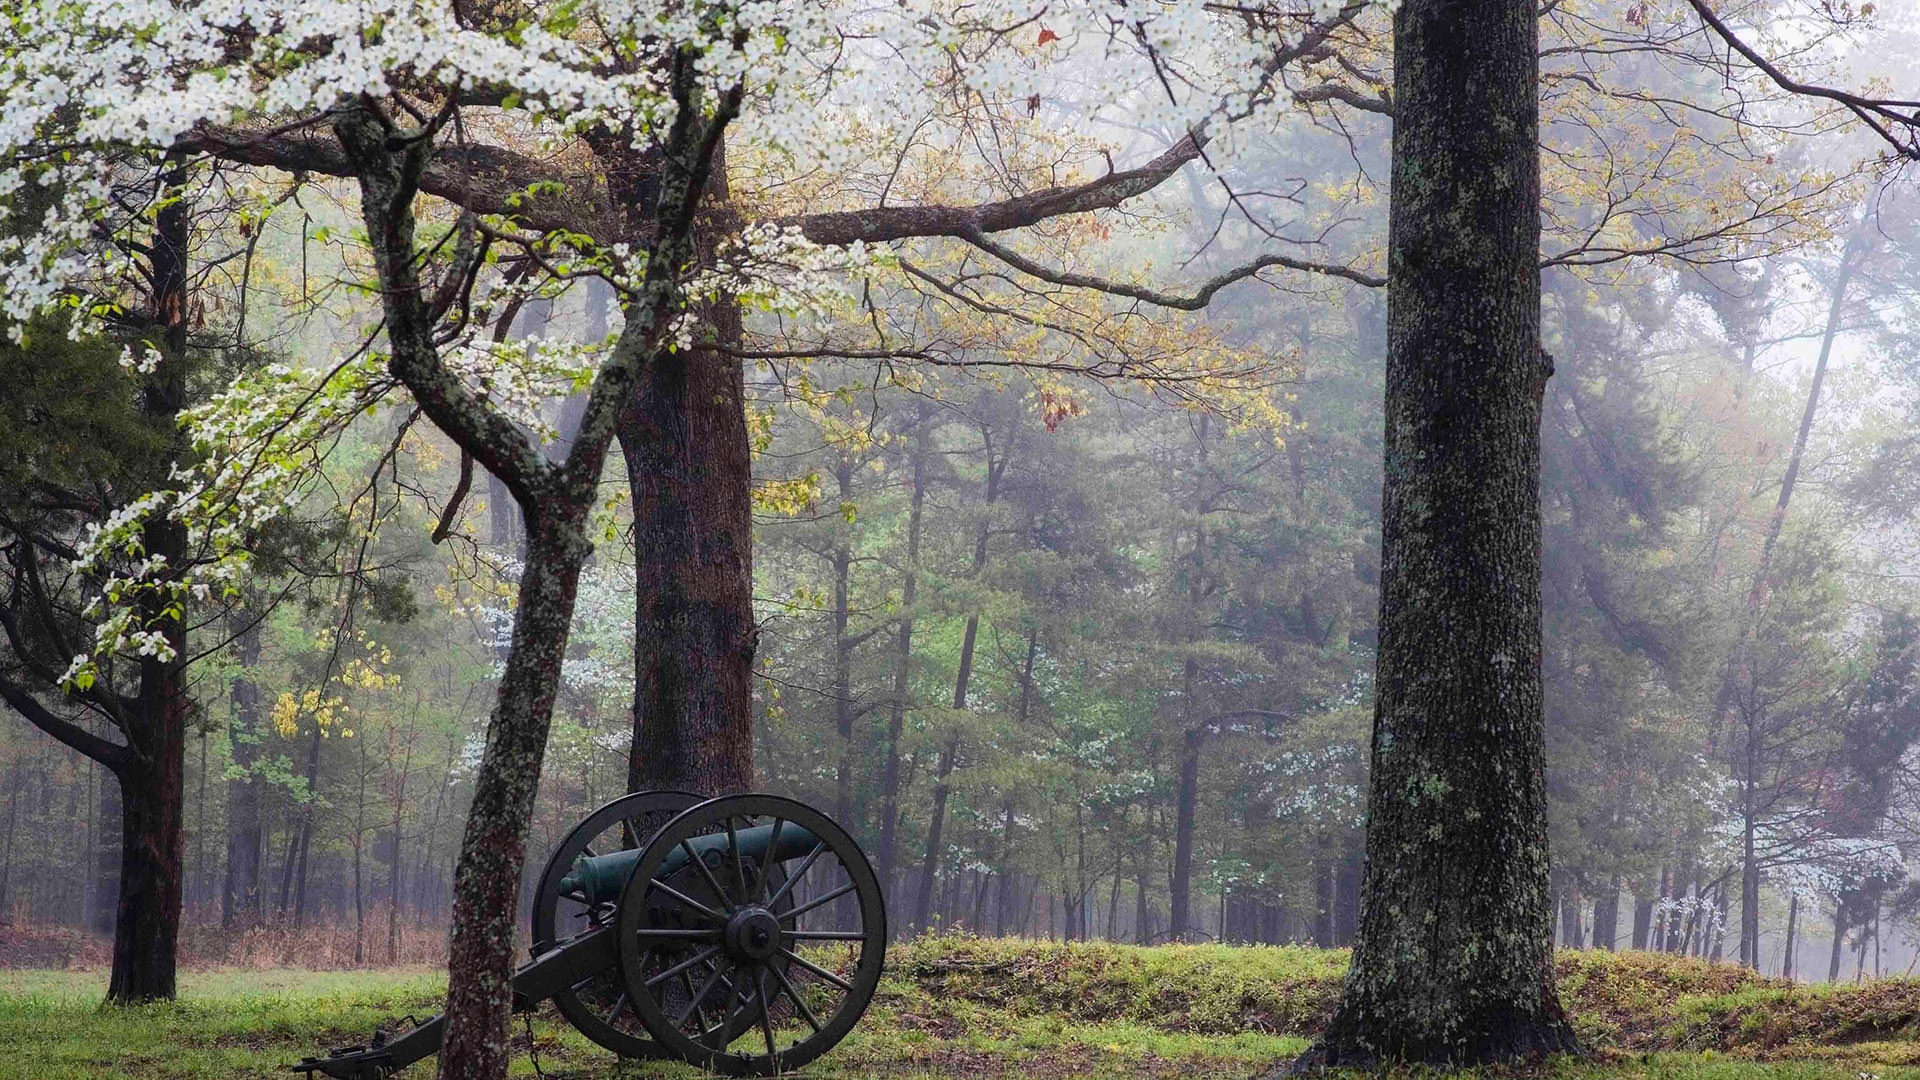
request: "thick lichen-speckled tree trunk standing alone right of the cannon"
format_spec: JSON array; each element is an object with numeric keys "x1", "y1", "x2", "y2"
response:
[{"x1": 1302, "y1": 0, "x2": 1576, "y2": 1067}]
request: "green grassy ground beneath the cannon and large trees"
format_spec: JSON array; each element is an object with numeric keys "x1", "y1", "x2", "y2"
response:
[{"x1": 11, "y1": 938, "x2": 1920, "y2": 1080}]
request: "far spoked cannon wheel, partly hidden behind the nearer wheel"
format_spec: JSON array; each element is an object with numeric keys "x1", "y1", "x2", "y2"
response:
[{"x1": 532, "y1": 792, "x2": 701, "y2": 1057}]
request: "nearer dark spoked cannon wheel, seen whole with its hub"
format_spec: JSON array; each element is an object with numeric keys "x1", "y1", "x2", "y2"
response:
[{"x1": 616, "y1": 796, "x2": 887, "y2": 1076}]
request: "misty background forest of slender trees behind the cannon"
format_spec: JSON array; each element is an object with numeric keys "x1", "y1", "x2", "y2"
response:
[{"x1": 0, "y1": 0, "x2": 1920, "y2": 980}]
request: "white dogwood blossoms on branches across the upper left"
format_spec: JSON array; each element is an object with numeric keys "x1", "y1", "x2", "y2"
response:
[{"x1": 0, "y1": 0, "x2": 1382, "y2": 682}]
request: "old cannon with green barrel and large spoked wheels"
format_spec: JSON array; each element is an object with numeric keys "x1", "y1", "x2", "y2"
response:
[{"x1": 294, "y1": 792, "x2": 887, "y2": 1080}]
